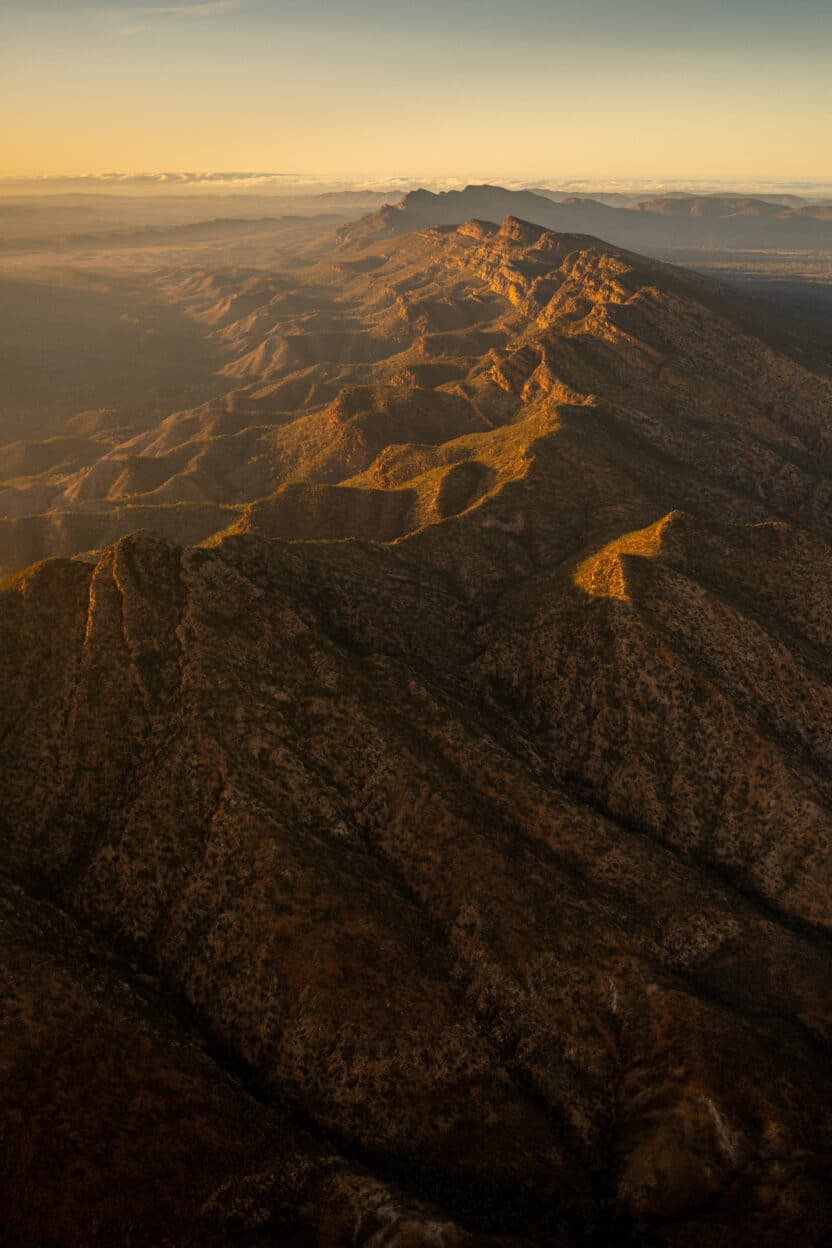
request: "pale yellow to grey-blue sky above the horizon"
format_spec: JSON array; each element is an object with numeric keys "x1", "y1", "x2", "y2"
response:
[{"x1": 0, "y1": 0, "x2": 832, "y2": 182}]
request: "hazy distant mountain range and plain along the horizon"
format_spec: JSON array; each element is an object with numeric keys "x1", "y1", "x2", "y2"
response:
[{"x1": 6, "y1": 185, "x2": 832, "y2": 262}]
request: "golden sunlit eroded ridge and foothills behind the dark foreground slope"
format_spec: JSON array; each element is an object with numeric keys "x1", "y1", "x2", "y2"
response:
[{"x1": 6, "y1": 218, "x2": 832, "y2": 573}]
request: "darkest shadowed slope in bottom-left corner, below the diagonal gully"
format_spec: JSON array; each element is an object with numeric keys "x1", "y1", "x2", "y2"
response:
[{"x1": 0, "y1": 881, "x2": 493, "y2": 1248}]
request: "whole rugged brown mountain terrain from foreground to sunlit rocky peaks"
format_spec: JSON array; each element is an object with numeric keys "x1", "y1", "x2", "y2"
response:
[{"x1": 0, "y1": 192, "x2": 832, "y2": 1248}]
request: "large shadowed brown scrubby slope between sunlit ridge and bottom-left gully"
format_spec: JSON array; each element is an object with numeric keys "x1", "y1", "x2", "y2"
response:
[{"x1": 1, "y1": 519, "x2": 831, "y2": 1244}]
